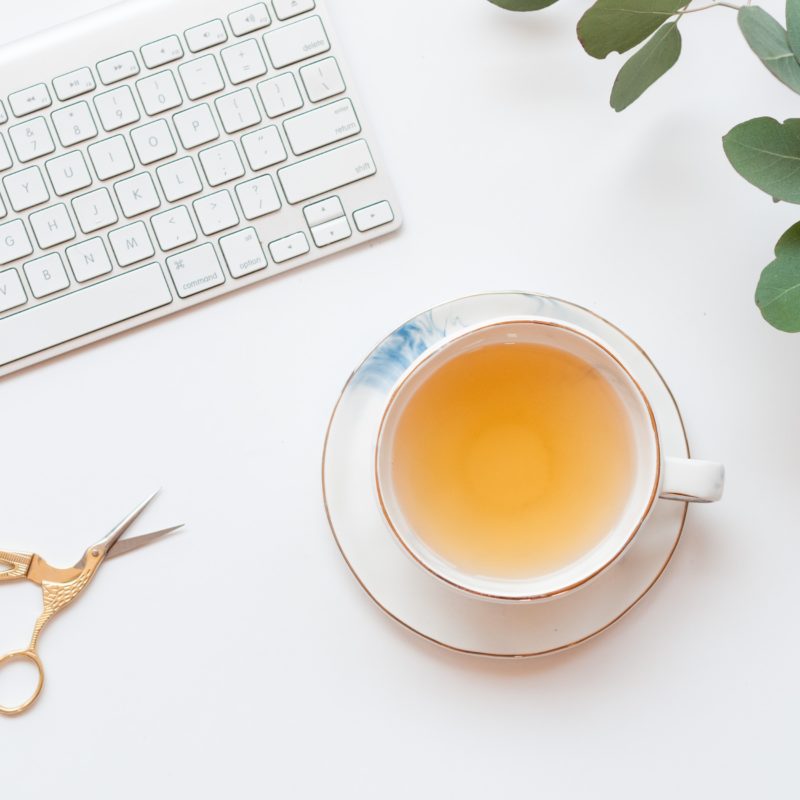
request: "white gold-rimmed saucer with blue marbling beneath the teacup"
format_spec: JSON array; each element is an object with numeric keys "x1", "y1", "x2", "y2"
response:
[{"x1": 322, "y1": 293, "x2": 689, "y2": 657}]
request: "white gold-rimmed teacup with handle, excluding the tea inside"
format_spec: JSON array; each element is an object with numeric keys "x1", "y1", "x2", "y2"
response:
[{"x1": 375, "y1": 319, "x2": 724, "y2": 601}]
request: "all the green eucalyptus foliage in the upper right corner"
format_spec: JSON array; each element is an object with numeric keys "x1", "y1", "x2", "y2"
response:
[{"x1": 490, "y1": 0, "x2": 800, "y2": 333}]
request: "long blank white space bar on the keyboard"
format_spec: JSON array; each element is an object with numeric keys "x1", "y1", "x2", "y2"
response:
[{"x1": 0, "y1": 264, "x2": 172, "y2": 367}]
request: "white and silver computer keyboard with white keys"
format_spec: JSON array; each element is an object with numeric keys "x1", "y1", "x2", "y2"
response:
[{"x1": 0, "y1": 0, "x2": 400, "y2": 376}]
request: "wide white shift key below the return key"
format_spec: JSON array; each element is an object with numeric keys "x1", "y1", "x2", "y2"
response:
[{"x1": 278, "y1": 139, "x2": 377, "y2": 204}]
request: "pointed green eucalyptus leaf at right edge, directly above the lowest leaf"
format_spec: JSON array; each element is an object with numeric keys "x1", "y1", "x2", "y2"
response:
[{"x1": 722, "y1": 117, "x2": 800, "y2": 203}]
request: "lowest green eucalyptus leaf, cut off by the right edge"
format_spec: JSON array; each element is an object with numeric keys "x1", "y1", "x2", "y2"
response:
[{"x1": 756, "y1": 222, "x2": 800, "y2": 333}]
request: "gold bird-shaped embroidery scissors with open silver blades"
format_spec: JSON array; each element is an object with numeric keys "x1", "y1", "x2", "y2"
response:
[{"x1": 0, "y1": 492, "x2": 183, "y2": 717}]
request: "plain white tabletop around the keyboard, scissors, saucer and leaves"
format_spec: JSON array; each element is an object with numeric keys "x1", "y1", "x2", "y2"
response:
[{"x1": 0, "y1": 0, "x2": 800, "y2": 800}]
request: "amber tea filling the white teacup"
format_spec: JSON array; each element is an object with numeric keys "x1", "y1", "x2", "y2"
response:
[{"x1": 392, "y1": 341, "x2": 636, "y2": 579}]
